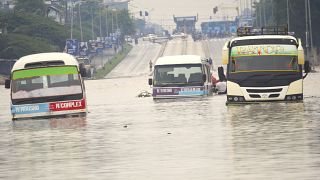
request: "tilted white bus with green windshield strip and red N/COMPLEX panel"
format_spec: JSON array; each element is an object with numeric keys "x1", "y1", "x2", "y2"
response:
[{"x1": 5, "y1": 53, "x2": 87, "y2": 120}]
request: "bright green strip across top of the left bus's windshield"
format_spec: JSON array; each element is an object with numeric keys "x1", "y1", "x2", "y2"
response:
[{"x1": 12, "y1": 66, "x2": 78, "y2": 80}]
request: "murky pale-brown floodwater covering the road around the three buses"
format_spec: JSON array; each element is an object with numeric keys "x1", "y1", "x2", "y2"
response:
[{"x1": 0, "y1": 39, "x2": 320, "y2": 180}]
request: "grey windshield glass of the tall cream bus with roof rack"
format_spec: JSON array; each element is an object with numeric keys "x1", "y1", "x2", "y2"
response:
[{"x1": 231, "y1": 56, "x2": 299, "y2": 73}]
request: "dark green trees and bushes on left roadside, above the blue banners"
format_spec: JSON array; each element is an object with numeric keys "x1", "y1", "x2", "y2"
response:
[{"x1": 0, "y1": 0, "x2": 134, "y2": 59}]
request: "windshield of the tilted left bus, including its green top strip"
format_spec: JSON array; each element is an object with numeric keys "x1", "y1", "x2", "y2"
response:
[{"x1": 12, "y1": 66, "x2": 82, "y2": 100}]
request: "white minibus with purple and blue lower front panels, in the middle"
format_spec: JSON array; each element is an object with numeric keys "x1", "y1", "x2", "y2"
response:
[{"x1": 149, "y1": 55, "x2": 213, "y2": 99}]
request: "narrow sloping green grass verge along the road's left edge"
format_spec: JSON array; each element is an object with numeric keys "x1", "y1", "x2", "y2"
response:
[{"x1": 94, "y1": 44, "x2": 132, "y2": 79}]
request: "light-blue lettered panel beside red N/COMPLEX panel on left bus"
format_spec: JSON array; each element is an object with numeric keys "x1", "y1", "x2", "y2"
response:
[{"x1": 11, "y1": 103, "x2": 49, "y2": 114}]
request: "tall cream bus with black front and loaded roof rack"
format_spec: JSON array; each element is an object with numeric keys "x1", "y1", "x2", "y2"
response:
[{"x1": 218, "y1": 27, "x2": 310, "y2": 104}]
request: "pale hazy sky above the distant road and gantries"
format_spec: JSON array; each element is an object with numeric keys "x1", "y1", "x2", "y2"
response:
[{"x1": 129, "y1": 0, "x2": 239, "y2": 28}]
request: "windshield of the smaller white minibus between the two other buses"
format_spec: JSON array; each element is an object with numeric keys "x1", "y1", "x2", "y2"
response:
[{"x1": 154, "y1": 64, "x2": 203, "y2": 87}]
